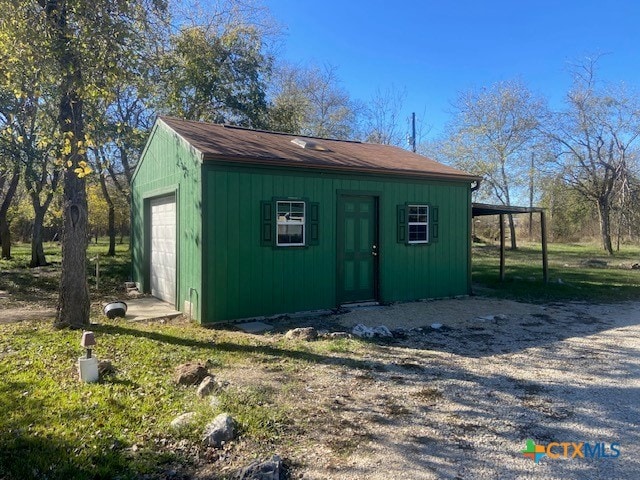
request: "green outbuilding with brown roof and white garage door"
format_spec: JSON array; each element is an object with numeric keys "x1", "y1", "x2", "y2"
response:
[{"x1": 132, "y1": 117, "x2": 479, "y2": 323}]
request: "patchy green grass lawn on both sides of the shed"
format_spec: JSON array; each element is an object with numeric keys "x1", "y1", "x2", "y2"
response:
[{"x1": 0, "y1": 238, "x2": 640, "y2": 479}]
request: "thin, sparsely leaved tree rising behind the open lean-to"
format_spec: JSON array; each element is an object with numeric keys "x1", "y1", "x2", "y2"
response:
[{"x1": 441, "y1": 81, "x2": 545, "y2": 249}]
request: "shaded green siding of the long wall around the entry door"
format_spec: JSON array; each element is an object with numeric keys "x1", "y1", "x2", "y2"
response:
[{"x1": 202, "y1": 163, "x2": 471, "y2": 322}]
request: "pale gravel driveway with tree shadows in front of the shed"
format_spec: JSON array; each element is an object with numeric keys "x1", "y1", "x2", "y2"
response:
[{"x1": 284, "y1": 299, "x2": 640, "y2": 480}]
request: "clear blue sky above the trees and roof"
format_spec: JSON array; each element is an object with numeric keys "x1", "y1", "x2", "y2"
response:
[{"x1": 265, "y1": 0, "x2": 640, "y2": 138}]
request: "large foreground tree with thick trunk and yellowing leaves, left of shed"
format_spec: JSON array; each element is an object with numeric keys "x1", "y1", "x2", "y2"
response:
[{"x1": 0, "y1": 0, "x2": 166, "y2": 328}]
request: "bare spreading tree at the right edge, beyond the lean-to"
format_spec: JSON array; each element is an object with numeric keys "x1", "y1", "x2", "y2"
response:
[{"x1": 546, "y1": 58, "x2": 640, "y2": 255}]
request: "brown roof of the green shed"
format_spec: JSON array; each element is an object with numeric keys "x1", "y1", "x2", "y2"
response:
[{"x1": 159, "y1": 117, "x2": 479, "y2": 182}]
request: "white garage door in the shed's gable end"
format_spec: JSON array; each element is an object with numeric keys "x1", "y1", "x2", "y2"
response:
[{"x1": 150, "y1": 195, "x2": 176, "y2": 305}]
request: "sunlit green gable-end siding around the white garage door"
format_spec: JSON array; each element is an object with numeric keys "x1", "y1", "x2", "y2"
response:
[{"x1": 131, "y1": 122, "x2": 203, "y2": 320}]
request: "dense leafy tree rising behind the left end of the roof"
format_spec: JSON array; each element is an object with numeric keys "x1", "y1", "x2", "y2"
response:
[{"x1": 155, "y1": 24, "x2": 271, "y2": 127}]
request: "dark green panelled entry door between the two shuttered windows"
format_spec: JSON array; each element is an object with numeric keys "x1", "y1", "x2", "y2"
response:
[{"x1": 337, "y1": 195, "x2": 378, "y2": 303}]
